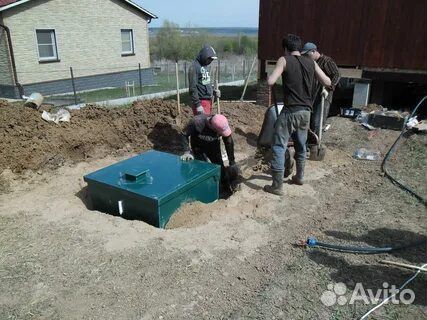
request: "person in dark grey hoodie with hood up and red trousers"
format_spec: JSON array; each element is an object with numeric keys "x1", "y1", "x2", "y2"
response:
[{"x1": 188, "y1": 46, "x2": 221, "y2": 115}]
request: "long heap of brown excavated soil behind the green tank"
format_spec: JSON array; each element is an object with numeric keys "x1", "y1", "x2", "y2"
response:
[{"x1": 0, "y1": 100, "x2": 263, "y2": 173}]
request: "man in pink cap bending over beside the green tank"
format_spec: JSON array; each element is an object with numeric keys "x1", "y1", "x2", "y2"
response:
[{"x1": 181, "y1": 114, "x2": 239, "y2": 192}]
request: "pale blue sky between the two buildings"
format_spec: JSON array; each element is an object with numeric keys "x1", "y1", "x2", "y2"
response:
[{"x1": 133, "y1": 0, "x2": 260, "y2": 28}]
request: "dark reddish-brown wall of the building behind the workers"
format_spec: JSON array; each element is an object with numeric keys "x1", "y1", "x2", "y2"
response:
[{"x1": 258, "y1": 0, "x2": 427, "y2": 71}]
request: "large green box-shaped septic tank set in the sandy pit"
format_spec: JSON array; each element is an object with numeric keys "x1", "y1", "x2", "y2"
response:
[{"x1": 83, "y1": 150, "x2": 221, "y2": 228}]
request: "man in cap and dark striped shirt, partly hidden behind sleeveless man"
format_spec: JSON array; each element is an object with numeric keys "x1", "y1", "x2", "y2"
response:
[{"x1": 301, "y1": 42, "x2": 340, "y2": 133}]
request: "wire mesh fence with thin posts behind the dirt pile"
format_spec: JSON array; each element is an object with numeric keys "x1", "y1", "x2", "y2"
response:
[{"x1": 8, "y1": 57, "x2": 258, "y2": 106}]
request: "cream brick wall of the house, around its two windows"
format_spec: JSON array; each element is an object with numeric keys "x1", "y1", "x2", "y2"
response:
[{"x1": 3, "y1": 0, "x2": 150, "y2": 84}]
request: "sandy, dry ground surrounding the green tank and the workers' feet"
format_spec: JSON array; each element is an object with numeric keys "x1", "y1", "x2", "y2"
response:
[{"x1": 0, "y1": 102, "x2": 427, "y2": 319}]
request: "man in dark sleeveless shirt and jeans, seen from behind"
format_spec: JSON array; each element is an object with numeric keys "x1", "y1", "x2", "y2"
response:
[{"x1": 264, "y1": 34, "x2": 331, "y2": 196}]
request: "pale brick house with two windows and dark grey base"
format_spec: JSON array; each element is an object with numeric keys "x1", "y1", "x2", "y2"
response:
[{"x1": 0, "y1": 0, "x2": 157, "y2": 98}]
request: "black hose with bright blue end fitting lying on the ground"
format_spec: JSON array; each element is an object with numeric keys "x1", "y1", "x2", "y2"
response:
[{"x1": 306, "y1": 237, "x2": 427, "y2": 254}]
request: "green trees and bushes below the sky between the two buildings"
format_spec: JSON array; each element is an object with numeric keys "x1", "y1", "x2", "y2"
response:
[{"x1": 150, "y1": 20, "x2": 258, "y2": 61}]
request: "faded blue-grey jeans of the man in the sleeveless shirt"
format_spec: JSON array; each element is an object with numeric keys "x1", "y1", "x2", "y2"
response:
[{"x1": 271, "y1": 109, "x2": 310, "y2": 171}]
